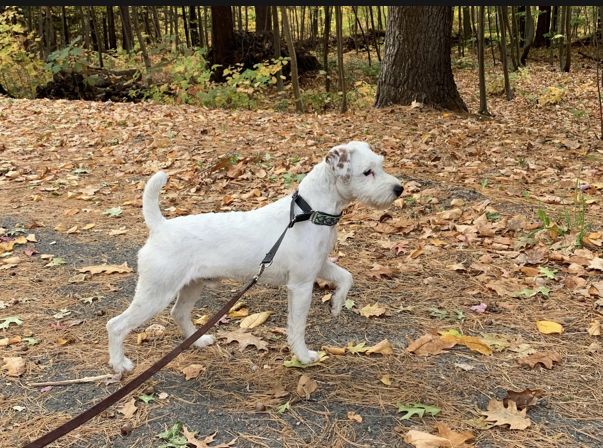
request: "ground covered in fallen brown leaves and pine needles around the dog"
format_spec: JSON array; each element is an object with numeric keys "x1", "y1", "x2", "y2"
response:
[{"x1": 0, "y1": 56, "x2": 603, "y2": 448}]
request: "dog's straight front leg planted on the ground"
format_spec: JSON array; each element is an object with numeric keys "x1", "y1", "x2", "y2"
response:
[{"x1": 287, "y1": 281, "x2": 320, "y2": 364}]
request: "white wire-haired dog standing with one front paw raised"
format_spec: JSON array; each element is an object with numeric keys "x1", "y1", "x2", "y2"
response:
[{"x1": 107, "y1": 141, "x2": 402, "y2": 373}]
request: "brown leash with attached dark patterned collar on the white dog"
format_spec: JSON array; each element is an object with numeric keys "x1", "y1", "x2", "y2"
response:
[{"x1": 24, "y1": 191, "x2": 341, "y2": 448}]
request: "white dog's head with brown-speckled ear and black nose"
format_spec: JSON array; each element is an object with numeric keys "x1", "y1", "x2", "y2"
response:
[{"x1": 325, "y1": 141, "x2": 403, "y2": 208}]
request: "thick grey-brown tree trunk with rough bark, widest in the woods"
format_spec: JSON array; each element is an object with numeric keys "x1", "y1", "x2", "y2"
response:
[{"x1": 375, "y1": 6, "x2": 467, "y2": 111}]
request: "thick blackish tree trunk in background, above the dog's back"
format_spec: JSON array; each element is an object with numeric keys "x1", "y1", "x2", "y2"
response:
[{"x1": 211, "y1": 6, "x2": 235, "y2": 81}]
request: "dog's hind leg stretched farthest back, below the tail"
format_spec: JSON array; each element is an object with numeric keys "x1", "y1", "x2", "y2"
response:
[{"x1": 107, "y1": 277, "x2": 178, "y2": 373}]
